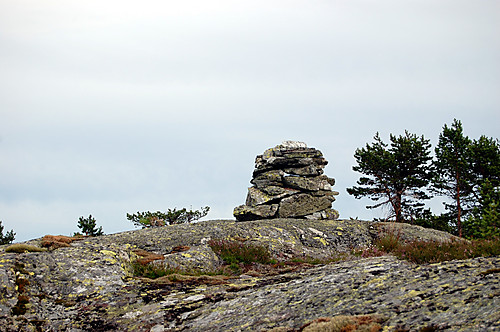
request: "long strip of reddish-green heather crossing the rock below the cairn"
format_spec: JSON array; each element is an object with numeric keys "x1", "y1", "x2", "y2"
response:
[{"x1": 132, "y1": 232, "x2": 500, "y2": 279}]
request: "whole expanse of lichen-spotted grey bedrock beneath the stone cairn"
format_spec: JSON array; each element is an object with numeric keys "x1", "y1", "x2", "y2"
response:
[{"x1": 0, "y1": 219, "x2": 500, "y2": 332}]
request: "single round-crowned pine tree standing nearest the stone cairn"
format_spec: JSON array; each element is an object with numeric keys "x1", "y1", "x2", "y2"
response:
[{"x1": 347, "y1": 131, "x2": 432, "y2": 222}]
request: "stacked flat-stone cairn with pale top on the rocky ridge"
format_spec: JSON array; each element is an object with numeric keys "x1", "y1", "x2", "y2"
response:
[{"x1": 233, "y1": 141, "x2": 339, "y2": 221}]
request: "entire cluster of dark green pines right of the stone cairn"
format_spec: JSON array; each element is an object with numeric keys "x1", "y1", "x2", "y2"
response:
[{"x1": 347, "y1": 119, "x2": 500, "y2": 239}]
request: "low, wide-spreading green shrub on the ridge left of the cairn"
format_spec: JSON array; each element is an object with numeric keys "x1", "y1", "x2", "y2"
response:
[{"x1": 127, "y1": 206, "x2": 210, "y2": 228}]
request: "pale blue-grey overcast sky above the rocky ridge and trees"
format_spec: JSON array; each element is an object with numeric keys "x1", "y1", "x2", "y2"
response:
[{"x1": 0, "y1": 0, "x2": 500, "y2": 241}]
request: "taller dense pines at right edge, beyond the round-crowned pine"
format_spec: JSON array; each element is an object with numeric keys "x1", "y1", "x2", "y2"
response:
[{"x1": 431, "y1": 119, "x2": 500, "y2": 238}]
